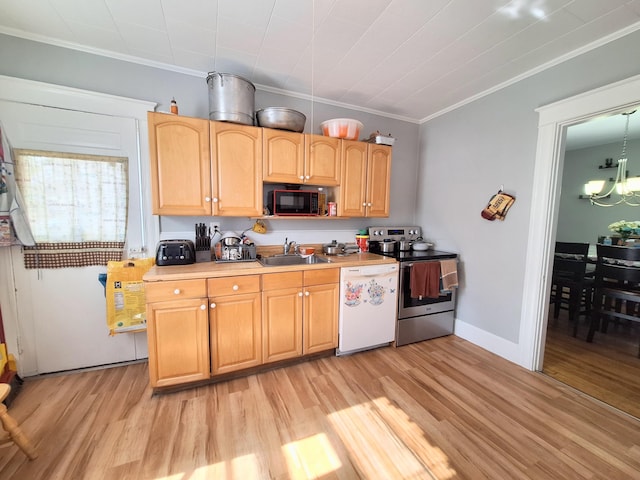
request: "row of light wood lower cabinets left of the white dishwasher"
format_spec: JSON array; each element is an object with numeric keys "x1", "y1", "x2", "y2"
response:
[{"x1": 145, "y1": 268, "x2": 340, "y2": 388}]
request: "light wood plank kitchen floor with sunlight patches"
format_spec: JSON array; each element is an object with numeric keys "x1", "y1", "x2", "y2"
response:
[{"x1": 0, "y1": 336, "x2": 640, "y2": 480}]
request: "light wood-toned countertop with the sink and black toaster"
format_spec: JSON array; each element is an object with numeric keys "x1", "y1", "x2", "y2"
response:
[{"x1": 142, "y1": 253, "x2": 396, "y2": 282}]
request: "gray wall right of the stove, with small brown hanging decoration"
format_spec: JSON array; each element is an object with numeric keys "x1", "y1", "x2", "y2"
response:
[{"x1": 416, "y1": 32, "x2": 640, "y2": 344}]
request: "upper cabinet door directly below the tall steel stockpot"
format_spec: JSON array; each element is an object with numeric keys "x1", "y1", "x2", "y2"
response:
[{"x1": 210, "y1": 122, "x2": 262, "y2": 216}]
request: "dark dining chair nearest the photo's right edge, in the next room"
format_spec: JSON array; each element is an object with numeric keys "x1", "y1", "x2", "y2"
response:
[{"x1": 587, "y1": 244, "x2": 640, "y2": 357}]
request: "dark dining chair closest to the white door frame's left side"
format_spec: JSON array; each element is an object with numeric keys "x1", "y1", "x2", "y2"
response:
[{"x1": 550, "y1": 242, "x2": 593, "y2": 337}]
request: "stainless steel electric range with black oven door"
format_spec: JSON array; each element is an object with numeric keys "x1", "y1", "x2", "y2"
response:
[{"x1": 369, "y1": 226, "x2": 458, "y2": 346}]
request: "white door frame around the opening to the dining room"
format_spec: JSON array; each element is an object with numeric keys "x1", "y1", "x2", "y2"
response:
[{"x1": 519, "y1": 75, "x2": 640, "y2": 371}]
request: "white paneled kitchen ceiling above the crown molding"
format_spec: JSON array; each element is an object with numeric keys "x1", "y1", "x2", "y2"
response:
[{"x1": 0, "y1": 0, "x2": 640, "y2": 122}]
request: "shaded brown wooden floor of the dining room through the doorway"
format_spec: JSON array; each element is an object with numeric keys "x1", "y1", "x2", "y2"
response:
[{"x1": 543, "y1": 311, "x2": 640, "y2": 418}]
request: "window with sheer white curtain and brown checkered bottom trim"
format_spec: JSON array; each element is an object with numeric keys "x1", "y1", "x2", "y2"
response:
[{"x1": 14, "y1": 150, "x2": 128, "y2": 268}]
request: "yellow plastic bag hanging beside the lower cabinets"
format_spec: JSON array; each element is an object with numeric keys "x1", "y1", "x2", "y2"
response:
[{"x1": 106, "y1": 258, "x2": 155, "y2": 335}]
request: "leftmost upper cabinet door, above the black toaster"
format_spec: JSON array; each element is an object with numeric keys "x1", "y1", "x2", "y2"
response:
[{"x1": 147, "y1": 112, "x2": 211, "y2": 215}]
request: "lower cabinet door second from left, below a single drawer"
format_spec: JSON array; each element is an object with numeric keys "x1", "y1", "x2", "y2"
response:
[{"x1": 209, "y1": 293, "x2": 262, "y2": 375}]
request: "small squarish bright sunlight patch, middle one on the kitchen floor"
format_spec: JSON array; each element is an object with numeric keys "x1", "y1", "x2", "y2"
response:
[{"x1": 282, "y1": 433, "x2": 342, "y2": 478}]
